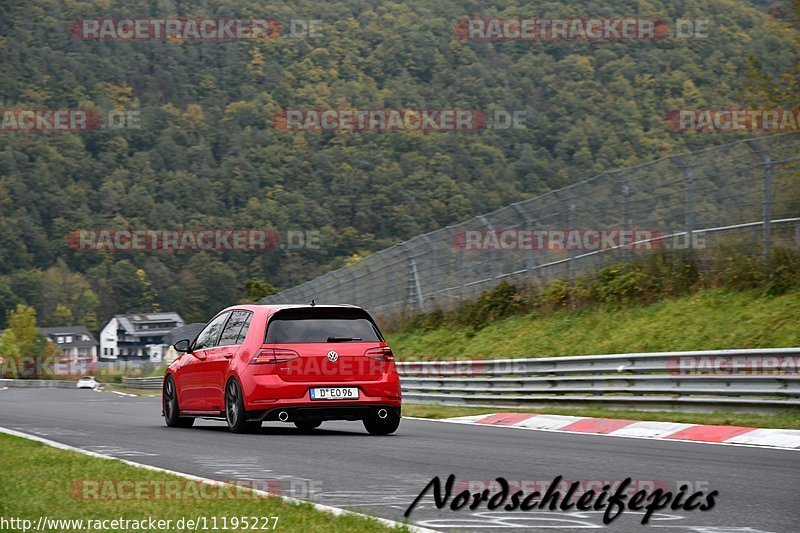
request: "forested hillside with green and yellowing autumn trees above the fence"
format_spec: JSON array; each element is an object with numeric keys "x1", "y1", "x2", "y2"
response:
[{"x1": 0, "y1": 0, "x2": 798, "y2": 325}]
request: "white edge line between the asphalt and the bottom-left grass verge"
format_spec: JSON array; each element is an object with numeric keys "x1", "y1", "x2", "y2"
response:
[{"x1": 0, "y1": 426, "x2": 439, "y2": 533}]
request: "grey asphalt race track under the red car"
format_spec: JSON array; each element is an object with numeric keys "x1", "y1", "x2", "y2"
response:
[{"x1": 0, "y1": 388, "x2": 800, "y2": 532}]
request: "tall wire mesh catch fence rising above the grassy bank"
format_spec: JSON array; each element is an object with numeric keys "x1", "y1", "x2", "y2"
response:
[{"x1": 260, "y1": 132, "x2": 800, "y2": 316}]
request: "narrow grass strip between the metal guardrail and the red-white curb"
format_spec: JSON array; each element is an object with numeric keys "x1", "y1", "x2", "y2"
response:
[{"x1": 403, "y1": 403, "x2": 800, "y2": 429}]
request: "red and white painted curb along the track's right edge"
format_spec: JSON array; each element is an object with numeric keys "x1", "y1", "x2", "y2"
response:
[{"x1": 434, "y1": 413, "x2": 800, "y2": 450}]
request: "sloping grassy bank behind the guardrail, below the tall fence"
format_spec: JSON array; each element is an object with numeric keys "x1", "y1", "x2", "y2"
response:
[{"x1": 387, "y1": 289, "x2": 800, "y2": 361}]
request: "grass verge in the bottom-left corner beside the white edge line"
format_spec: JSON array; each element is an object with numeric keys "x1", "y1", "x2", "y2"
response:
[{"x1": 0, "y1": 434, "x2": 405, "y2": 533}]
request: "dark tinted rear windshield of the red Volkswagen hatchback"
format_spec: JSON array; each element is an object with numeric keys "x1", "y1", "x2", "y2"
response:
[{"x1": 265, "y1": 308, "x2": 383, "y2": 344}]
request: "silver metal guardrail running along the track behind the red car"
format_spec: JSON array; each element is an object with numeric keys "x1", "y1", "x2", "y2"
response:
[{"x1": 122, "y1": 348, "x2": 800, "y2": 410}]
